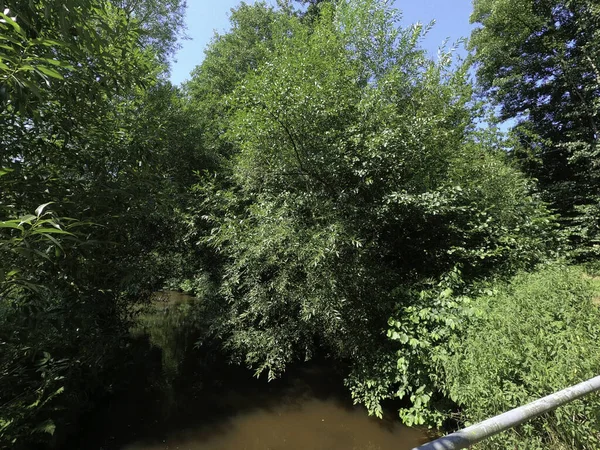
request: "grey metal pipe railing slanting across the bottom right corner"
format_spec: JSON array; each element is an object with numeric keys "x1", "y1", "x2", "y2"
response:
[{"x1": 413, "y1": 376, "x2": 600, "y2": 450}]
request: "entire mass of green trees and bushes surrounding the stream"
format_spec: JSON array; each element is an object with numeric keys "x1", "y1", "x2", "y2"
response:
[{"x1": 0, "y1": 0, "x2": 600, "y2": 449}]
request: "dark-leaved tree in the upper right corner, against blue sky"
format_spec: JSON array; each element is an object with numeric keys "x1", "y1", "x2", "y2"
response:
[{"x1": 470, "y1": 0, "x2": 600, "y2": 255}]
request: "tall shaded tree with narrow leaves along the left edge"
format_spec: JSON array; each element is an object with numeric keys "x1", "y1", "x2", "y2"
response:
[{"x1": 0, "y1": 0, "x2": 192, "y2": 448}]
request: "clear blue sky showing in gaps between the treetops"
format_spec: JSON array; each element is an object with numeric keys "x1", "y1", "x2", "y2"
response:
[{"x1": 171, "y1": 0, "x2": 472, "y2": 84}]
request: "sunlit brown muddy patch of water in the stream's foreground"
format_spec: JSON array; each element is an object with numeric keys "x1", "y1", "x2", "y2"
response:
[{"x1": 124, "y1": 369, "x2": 427, "y2": 450}]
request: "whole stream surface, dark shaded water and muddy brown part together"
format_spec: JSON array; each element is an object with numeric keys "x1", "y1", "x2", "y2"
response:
[{"x1": 59, "y1": 296, "x2": 427, "y2": 450}]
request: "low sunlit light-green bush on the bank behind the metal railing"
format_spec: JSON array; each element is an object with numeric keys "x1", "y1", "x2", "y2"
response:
[{"x1": 444, "y1": 266, "x2": 600, "y2": 450}]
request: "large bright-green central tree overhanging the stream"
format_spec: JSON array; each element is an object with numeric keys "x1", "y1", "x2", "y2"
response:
[{"x1": 198, "y1": 0, "x2": 552, "y2": 415}]
